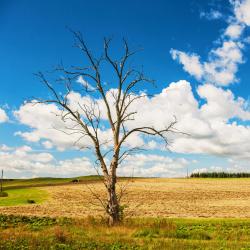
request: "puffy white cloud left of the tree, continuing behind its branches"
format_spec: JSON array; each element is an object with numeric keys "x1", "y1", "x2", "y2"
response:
[{"x1": 14, "y1": 97, "x2": 146, "y2": 151}]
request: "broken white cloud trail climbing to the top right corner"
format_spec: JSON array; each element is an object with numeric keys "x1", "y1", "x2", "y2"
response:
[{"x1": 170, "y1": 0, "x2": 250, "y2": 86}]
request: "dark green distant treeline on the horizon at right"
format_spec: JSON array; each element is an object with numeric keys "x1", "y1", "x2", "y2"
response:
[{"x1": 190, "y1": 172, "x2": 250, "y2": 178}]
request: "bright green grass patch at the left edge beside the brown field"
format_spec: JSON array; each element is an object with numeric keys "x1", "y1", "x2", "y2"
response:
[{"x1": 0, "y1": 188, "x2": 48, "y2": 206}]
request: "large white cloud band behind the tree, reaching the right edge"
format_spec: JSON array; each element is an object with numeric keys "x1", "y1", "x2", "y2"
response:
[{"x1": 15, "y1": 80, "x2": 250, "y2": 159}]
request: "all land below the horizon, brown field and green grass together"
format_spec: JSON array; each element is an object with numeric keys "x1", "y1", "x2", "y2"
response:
[{"x1": 0, "y1": 177, "x2": 250, "y2": 249}]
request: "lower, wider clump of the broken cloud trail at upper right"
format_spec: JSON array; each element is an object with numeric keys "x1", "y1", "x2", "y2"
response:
[{"x1": 170, "y1": 41, "x2": 244, "y2": 86}]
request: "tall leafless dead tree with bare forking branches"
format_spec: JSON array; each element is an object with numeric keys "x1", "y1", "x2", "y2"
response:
[{"x1": 37, "y1": 32, "x2": 176, "y2": 225}]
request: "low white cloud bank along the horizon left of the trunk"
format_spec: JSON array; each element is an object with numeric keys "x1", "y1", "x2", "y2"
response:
[{"x1": 0, "y1": 146, "x2": 96, "y2": 178}]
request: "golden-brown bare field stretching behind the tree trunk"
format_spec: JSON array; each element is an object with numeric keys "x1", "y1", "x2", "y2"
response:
[{"x1": 0, "y1": 178, "x2": 250, "y2": 218}]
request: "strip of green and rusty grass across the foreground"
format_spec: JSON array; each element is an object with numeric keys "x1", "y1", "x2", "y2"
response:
[{"x1": 0, "y1": 215, "x2": 250, "y2": 249}]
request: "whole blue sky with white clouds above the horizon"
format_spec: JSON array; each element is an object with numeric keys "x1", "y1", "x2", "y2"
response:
[{"x1": 0, "y1": 0, "x2": 250, "y2": 178}]
